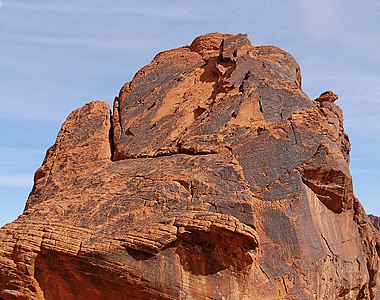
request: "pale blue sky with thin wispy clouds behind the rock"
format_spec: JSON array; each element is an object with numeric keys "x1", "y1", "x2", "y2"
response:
[{"x1": 0, "y1": 0, "x2": 380, "y2": 225}]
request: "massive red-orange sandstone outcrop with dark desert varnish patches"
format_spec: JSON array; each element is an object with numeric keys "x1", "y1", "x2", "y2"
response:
[{"x1": 0, "y1": 33, "x2": 380, "y2": 299}]
